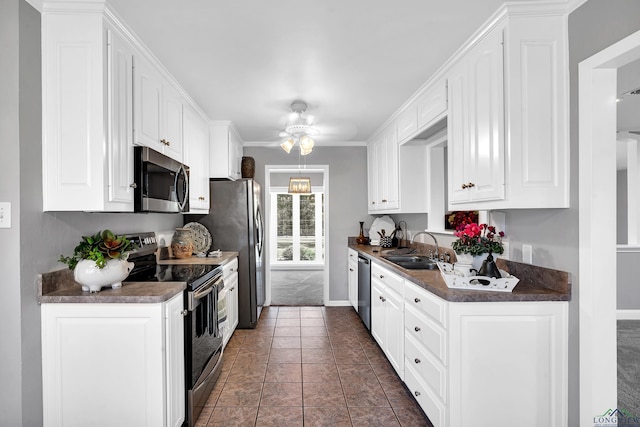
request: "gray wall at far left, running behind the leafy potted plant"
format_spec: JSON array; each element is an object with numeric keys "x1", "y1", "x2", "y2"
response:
[{"x1": 0, "y1": 0, "x2": 182, "y2": 427}]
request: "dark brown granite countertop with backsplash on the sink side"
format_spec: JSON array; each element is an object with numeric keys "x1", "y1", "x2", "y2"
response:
[{"x1": 348, "y1": 237, "x2": 571, "y2": 302}]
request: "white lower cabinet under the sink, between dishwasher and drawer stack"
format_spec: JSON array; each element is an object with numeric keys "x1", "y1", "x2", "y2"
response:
[{"x1": 371, "y1": 263, "x2": 404, "y2": 378}]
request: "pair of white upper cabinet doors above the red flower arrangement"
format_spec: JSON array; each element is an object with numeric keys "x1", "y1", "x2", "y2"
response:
[{"x1": 448, "y1": 24, "x2": 504, "y2": 204}]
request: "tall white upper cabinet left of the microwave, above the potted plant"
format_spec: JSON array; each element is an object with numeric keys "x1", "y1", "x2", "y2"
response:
[{"x1": 42, "y1": 13, "x2": 133, "y2": 211}]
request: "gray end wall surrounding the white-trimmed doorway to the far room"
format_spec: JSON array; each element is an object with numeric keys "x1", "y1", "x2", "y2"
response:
[{"x1": 244, "y1": 147, "x2": 373, "y2": 301}]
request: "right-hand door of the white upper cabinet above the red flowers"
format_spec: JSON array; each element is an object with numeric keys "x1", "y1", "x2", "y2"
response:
[{"x1": 467, "y1": 28, "x2": 504, "y2": 200}]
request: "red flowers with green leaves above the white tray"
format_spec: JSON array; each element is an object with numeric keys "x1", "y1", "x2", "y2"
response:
[{"x1": 451, "y1": 223, "x2": 504, "y2": 256}]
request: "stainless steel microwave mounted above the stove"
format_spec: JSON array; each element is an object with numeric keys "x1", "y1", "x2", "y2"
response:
[{"x1": 133, "y1": 147, "x2": 189, "y2": 213}]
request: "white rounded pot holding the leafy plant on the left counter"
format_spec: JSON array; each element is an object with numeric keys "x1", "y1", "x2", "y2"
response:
[{"x1": 73, "y1": 259, "x2": 134, "y2": 292}]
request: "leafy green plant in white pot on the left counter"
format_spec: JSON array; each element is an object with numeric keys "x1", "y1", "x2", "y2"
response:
[{"x1": 58, "y1": 230, "x2": 134, "y2": 292}]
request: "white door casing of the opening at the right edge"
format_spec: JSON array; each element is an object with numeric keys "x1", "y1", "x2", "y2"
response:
[{"x1": 578, "y1": 27, "x2": 640, "y2": 426}]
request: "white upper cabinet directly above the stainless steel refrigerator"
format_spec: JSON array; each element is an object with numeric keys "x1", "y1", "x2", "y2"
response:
[{"x1": 209, "y1": 120, "x2": 242, "y2": 181}]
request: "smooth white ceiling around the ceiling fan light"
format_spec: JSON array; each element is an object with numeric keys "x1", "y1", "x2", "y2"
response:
[{"x1": 108, "y1": 0, "x2": 556, "y2": 145}]
